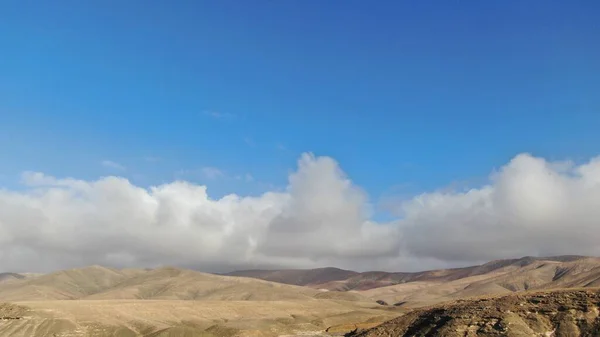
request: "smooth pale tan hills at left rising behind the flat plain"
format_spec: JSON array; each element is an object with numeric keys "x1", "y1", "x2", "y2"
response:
[{"x1": 0, "y1": 266, "x2": 356, "y2": 301}]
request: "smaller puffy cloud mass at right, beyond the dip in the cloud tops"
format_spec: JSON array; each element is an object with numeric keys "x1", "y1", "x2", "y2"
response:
[{"x1": 399, "y1": 154, "x2": 600, "y2": 261}]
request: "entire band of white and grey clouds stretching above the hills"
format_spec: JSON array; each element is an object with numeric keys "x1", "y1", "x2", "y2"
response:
[{"x1": 0, "y1": 154, "x2": 600, "y2": 271}]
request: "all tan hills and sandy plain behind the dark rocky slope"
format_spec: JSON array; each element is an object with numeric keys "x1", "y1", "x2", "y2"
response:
[{"x1": 0, "y1": 256, "x2": 600, "y2": 337}]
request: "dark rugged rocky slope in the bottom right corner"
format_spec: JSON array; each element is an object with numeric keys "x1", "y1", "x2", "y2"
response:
[{"x1": 346, "y1": 289, "x2": 600, "y2": 337}]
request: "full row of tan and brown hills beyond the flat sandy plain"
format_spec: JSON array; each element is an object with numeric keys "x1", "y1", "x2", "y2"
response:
[{"x1": 0, "y1": 256, "x2": 600, "y2": 307}]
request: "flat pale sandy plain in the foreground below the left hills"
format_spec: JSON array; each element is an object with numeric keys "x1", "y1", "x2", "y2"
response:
[{"x1": 0, "y1": 300, "x2": 398, "y2": 337}]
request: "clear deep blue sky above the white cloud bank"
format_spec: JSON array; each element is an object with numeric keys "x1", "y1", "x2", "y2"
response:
[{"x1": 0, "y1": 0, "x2": 600, "y2": 201}]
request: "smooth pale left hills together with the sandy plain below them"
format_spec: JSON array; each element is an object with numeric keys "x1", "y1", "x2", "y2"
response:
[{"x1": 0, "y1": 266, "x2": 398, "y2": 337}]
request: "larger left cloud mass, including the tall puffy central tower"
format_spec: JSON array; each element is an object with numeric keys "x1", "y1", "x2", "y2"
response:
[{"x1": 0, "y1": 154, "x2": 396, "y2": 271}]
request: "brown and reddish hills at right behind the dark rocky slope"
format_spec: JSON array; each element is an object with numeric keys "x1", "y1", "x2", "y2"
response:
[{"x1": 227, "y1": 255, "x2": 600, "y2": 305}]
